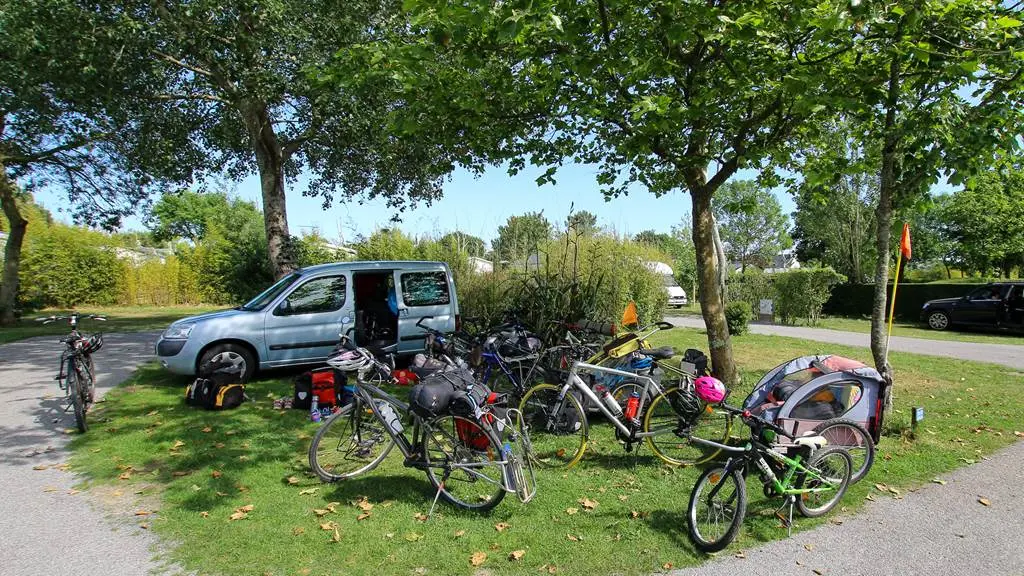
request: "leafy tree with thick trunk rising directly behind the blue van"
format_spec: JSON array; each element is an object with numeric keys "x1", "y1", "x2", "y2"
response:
[{"x1": 104, "y1": 0, "x2": 464, "y2": 277}]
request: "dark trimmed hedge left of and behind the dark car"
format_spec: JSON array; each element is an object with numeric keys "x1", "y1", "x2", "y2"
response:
[{"x1": 822, "y1": 282, "x2": 976, "y2": 322}]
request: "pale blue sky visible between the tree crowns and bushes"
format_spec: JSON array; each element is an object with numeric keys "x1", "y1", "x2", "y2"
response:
[{"x1": 37, "y1": 165, "x2": 794, "y2": 247}]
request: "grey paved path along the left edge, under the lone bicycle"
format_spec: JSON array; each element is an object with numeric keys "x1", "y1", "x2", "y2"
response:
[{"x1": 0, "y1": 333, "x2": 177, "y2": 576}]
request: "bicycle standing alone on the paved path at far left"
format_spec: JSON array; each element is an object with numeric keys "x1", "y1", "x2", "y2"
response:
[{"x1": 36, "y1": 313, "x2": 106, "y2": 433}]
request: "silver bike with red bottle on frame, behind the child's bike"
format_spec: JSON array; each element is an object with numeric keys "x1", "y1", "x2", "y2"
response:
[{"x1": 519, "y1": 348, "x2": 732, "y2": 467}]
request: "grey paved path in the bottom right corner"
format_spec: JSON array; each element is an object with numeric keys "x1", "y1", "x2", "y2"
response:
[{"x1": 673, "y1": 442, "x2": 1024, "y2": 576}]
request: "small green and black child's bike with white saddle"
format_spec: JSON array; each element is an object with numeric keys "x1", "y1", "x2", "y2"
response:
[{"x1": 686, "y1": 405, "x2": 853, "y2": 552}]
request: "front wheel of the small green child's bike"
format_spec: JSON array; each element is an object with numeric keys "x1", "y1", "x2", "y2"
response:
[{"x1": 686, "y1": 466, "x2": 746, "y2": 552}]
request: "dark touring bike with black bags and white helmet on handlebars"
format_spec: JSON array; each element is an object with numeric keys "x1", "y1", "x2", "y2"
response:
[{"x1": 308, "y1": 330, "x2": 537, "y2": 516}]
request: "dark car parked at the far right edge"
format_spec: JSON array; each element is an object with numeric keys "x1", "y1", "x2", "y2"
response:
[{"x1": 921, "y1": 281, "x2": 1024, "y2": 331}]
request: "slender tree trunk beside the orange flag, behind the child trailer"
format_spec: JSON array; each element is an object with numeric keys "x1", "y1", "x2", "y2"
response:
[{"x1": 871, "y1": 51, "x2": 900, "y2": 406}]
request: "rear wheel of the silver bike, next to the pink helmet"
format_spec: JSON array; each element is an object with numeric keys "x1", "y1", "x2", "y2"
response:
[{"x1": 643, "y1": 387, "x2": 732, "y2": 466}]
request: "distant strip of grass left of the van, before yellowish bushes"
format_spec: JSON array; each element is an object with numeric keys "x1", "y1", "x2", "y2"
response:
[{"x1": 0, "y1": 305, "x2": 225, "y2": 344}]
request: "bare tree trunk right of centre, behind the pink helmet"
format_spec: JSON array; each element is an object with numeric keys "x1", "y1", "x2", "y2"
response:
[{"x1": 689, "y1": 181, "x2": 737, "y2": 385}]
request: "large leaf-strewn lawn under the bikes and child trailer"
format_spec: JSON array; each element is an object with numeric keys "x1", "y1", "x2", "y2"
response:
[{"x1": 71, "y1": 329, "x2": 1024, "y2": 575}]
